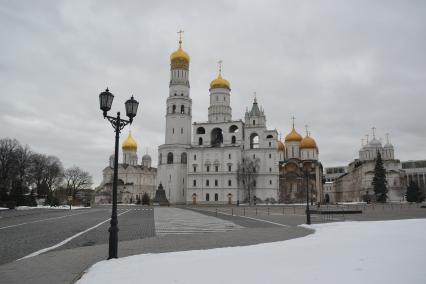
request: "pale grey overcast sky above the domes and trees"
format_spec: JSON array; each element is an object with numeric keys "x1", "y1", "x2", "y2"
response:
[{"x1": 0, "y1": 0, "x2": 426, "y2": 186}]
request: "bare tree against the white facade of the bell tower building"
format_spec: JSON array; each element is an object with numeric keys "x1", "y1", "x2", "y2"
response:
[{"x1": 237, "y1": 156, "x2": 259, "y2": 205}]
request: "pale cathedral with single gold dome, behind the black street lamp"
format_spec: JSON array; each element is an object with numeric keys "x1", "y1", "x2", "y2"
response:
[{"x1": 94, "y1": 132, "x2": 157, "y2": 204}]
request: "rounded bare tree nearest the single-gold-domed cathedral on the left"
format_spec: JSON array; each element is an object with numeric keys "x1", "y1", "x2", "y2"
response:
[{"x1": 64, "y1": 166, "x2": 93, "y2": 199}]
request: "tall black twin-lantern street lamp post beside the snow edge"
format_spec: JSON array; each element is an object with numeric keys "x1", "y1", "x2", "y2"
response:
[{"x1": 99, "y1": 89, "x2": 139, "y2": 259}]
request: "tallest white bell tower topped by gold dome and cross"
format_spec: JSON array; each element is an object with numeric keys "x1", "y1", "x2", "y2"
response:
[{"x1": 157, "y1": 31, "x2": 192, "y2": 204}]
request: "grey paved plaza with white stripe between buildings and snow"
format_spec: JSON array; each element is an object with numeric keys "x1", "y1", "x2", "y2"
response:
[{"x1": 0, "y1": 204, "x2": 426, "y2": 283}]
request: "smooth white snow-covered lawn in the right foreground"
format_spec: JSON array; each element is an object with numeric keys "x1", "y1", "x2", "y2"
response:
[{"x1": 78, "y1": 219, "x2": 426, "y2": 284}]
